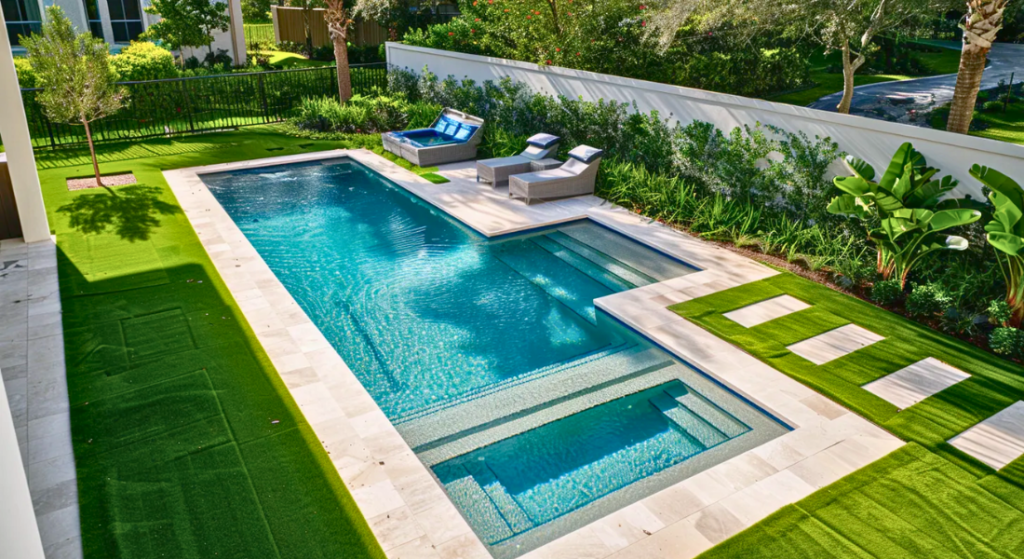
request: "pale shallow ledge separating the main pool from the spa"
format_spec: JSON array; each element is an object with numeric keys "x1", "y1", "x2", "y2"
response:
[{"x1": 396, "y1": 345, "x2": 673, "y2": 448}]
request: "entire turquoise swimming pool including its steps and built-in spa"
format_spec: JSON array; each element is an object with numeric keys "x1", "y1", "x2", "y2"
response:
[{"x1": 203, "y1": 159, "x2": 785, "y2": 557}]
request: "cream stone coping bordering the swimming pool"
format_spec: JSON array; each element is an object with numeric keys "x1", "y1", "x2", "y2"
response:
[{"x1": 164, "y1": 149, "x2": 903, "y2": 559}]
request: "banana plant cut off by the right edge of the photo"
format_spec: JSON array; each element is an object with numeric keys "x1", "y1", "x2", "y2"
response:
[{"x1": 971, "y1": 165, "x2": 1024, "y2": 327}]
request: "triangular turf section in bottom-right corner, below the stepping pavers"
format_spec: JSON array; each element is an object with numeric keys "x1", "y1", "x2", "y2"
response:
[{"x1": 700, "y1": 443, "x2": 1024, "y2": 559}]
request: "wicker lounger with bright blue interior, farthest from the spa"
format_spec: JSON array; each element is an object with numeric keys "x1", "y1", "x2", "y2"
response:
[{"x1": 381, "y1": 109, "x2": 483, "y2": 167}]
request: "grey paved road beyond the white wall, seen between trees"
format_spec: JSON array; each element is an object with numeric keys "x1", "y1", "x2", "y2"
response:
[{"x1": 810, "y1": 42, "x2": 1024, "y2": 118}]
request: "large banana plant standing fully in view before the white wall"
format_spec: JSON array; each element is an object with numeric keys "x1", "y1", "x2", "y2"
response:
[{"x1": 828, "y1": 143, "x2": 981, "y2": 286}]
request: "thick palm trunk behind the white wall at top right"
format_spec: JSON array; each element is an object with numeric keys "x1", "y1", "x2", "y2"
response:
[{"x1": 946, "y1": 0, "x2": 1008, "y2": 134}]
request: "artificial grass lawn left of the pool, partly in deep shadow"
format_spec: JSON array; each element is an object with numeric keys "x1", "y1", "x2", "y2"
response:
[{"x1": 38, "y1": 127, "x2": 384, "y2": 559}]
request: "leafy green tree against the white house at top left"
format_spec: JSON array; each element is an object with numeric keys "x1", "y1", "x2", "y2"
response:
[{"x1": 141, "y1": 0, "x2": 230, "y2": 68}]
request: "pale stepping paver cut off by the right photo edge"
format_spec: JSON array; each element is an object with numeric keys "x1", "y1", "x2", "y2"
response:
[{"x1": 949, "y1": 401, "x2": 1024, "y2": 470}]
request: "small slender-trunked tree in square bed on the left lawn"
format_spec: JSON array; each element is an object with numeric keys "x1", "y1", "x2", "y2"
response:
[{"x1": 22, "y1": 6, "x2": 127, "y2": 186}]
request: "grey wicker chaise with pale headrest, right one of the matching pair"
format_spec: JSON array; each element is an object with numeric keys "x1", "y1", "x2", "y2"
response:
[{"x1": 509, "y1": 145, "x2": 604, "y2": 204}]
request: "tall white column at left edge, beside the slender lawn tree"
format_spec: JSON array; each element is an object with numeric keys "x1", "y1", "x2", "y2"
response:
[{"x1": 0, "y1": 8, "x2": 50, "y2": 243}]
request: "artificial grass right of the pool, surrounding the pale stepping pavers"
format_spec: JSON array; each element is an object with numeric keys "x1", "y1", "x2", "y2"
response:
[{"x1": 672, "y1": 273, "x2": 1024, "y2": 558}]
